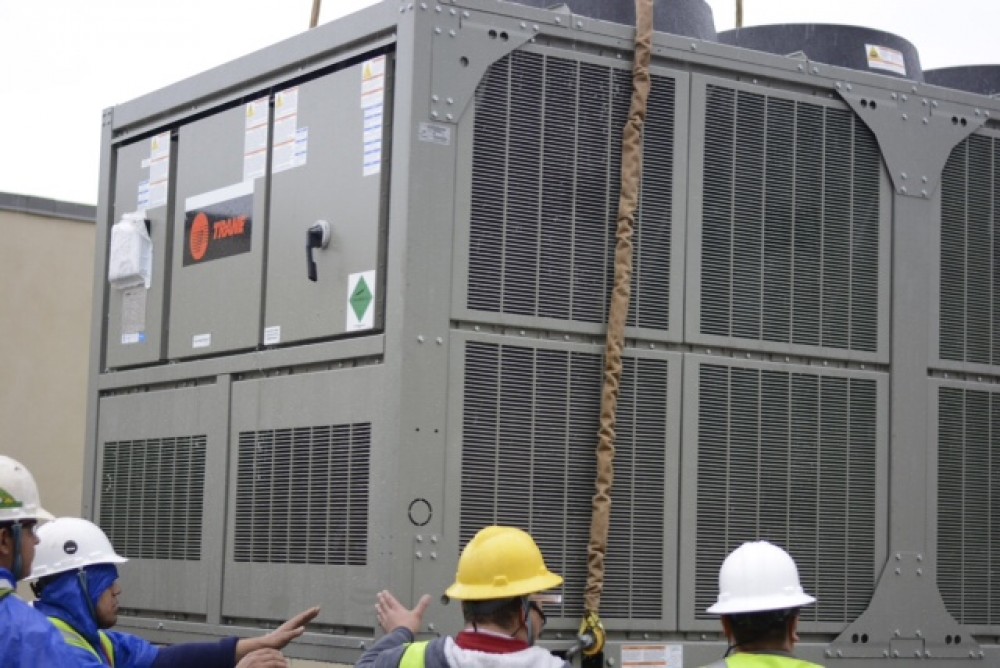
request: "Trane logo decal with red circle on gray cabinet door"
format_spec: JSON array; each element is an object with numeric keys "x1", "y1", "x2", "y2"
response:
[{"x1": 184, "y1": 181, "x2": 253, "y2": 267}]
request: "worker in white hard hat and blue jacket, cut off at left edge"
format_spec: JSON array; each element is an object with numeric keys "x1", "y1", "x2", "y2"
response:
[{"x1": 0, "y1": 455, "x2": 84, "y2": 668}]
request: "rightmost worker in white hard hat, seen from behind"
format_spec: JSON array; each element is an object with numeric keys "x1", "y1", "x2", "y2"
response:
[{"x1": 706, "y1": 541, "x2": 821, "y2": 668}]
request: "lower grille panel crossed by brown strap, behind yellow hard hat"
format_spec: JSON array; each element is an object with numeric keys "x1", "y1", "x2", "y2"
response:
[{"x1": 448, "y1": 332, "x2": 682, "y2": 638}]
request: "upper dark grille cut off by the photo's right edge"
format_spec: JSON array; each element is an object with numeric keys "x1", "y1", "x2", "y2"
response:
[{"x1": 939, "y1": 135, "x2": 1000, "y2": 364}]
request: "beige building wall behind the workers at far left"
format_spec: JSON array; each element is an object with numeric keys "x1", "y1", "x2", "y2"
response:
[{"x1": 0, "y1": 193, "x2": 95, "y2": 515}]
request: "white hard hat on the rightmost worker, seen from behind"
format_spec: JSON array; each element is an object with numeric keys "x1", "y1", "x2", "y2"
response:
[{"x1": 705, "y1": 541, "x2": 816, "y2": 615}]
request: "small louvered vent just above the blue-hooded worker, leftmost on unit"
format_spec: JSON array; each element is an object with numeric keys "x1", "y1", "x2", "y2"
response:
[{"x1": 99, "y1": 435, "x2": 206, "y2": 561}]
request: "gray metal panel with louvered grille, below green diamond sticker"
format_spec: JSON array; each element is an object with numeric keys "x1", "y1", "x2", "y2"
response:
[{"x1": 223, "y1": 366, "x2": 388, "y2": 635}]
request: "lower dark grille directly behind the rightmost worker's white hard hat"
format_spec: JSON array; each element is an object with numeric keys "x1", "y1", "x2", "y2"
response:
[{"x1": 694, "y1": 364, "x2": 878, "y2": 623}]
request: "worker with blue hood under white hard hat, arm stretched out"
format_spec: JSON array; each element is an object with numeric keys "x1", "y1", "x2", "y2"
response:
[{"x1": 29, "y1": 517, "x2": 319, "y2": 668}]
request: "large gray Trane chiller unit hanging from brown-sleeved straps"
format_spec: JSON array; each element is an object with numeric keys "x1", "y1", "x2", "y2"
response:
[{"x1": 85, "y1": 0, "x2": 1000, "y2": 668}]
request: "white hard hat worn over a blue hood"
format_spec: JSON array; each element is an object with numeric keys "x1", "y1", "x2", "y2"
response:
[{"x1": 25, "y1": 517, "x2": 128, "y2": 581}]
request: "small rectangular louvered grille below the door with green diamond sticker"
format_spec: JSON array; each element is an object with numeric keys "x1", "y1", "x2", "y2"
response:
[{"x1": 233, "y1": 423, "x2": 371, "y2": 566}]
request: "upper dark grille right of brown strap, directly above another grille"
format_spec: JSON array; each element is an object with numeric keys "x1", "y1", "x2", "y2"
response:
[{"x1": 701, "y1": 85, "x2": 882, "y2": 352}]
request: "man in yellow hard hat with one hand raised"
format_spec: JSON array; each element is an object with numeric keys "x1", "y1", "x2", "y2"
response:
[{"x1": 355, "y1": 526, "x2": 569, "y2": 668}]
